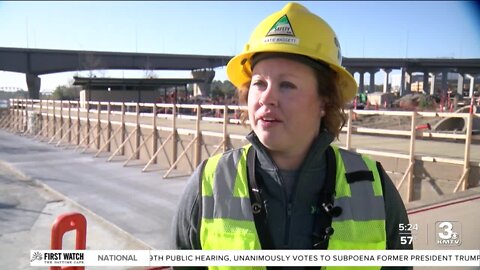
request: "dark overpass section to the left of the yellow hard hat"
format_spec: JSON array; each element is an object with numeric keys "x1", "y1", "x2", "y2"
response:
[{"x1": 0, "y1": 48, "x2": 231, "y2": 99}]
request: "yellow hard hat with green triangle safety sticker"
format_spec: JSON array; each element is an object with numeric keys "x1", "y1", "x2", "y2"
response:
[{"x1": 227, "y1": 3, "x2": 357, "y2": 102}]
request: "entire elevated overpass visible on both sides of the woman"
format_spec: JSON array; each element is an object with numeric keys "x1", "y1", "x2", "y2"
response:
[{"x1": 0, "y1": 47, "x2": 480, "y2": 99}]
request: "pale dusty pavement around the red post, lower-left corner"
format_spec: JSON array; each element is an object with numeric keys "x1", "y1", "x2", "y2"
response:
[{"x1": 0, "y1": 157, "x2": 148, "y2": 270}]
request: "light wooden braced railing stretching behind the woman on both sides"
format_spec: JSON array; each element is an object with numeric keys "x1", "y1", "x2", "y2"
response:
[{"x1": 0, "y1": 99, "x2": 480, "y2": 201}]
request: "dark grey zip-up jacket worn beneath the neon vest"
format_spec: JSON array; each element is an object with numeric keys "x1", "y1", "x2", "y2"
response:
[{"x1": 173, "y1": 132, "x2": 413, "y2": 269}]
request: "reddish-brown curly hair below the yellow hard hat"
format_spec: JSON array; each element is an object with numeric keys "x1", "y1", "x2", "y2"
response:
[{"x1": 238, "y1": 59, "x2": 346, "y2": 138}]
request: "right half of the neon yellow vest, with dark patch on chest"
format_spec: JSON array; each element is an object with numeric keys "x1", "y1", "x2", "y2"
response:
[{"x1": 322, "y1": 146, "x2": 387, "y2": 270}]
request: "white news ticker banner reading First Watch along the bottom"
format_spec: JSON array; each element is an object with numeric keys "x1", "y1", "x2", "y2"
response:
[{"x1": 29, "y1": 250, "x2": 480, "y2": 266}]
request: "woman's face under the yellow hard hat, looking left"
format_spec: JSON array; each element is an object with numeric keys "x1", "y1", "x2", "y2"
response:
[{"x1": 248, "y1": 58, "x2": 325, "y2": 154}]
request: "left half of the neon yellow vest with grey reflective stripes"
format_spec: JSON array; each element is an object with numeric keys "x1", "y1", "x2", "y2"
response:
[{"x1": 200, "y1": 144, "x2": 261, "y2": 250}]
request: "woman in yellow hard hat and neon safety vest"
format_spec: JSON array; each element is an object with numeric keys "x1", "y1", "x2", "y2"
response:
[{"x1": 174, "y1": 3, "x2": 412, "y2": 269}]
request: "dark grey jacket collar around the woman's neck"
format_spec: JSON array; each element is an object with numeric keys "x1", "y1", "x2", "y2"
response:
[{"x1": 246, "y1": 131, "x2": 335, "y2": 171}]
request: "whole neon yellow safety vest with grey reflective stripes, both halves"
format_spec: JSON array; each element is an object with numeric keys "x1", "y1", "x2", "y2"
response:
[{"x1": 200, "y1": 144, "x2": 386, "y2": 269}]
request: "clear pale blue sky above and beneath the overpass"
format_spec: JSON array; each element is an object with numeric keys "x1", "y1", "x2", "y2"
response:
[{"x1": 0, "y1": 1, "x2": 480, "y2": 91}]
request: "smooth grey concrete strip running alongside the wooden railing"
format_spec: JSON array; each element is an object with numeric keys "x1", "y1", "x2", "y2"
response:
[{"x1": 0, "y1": 130, "x2": 186, "y2": 249}]
